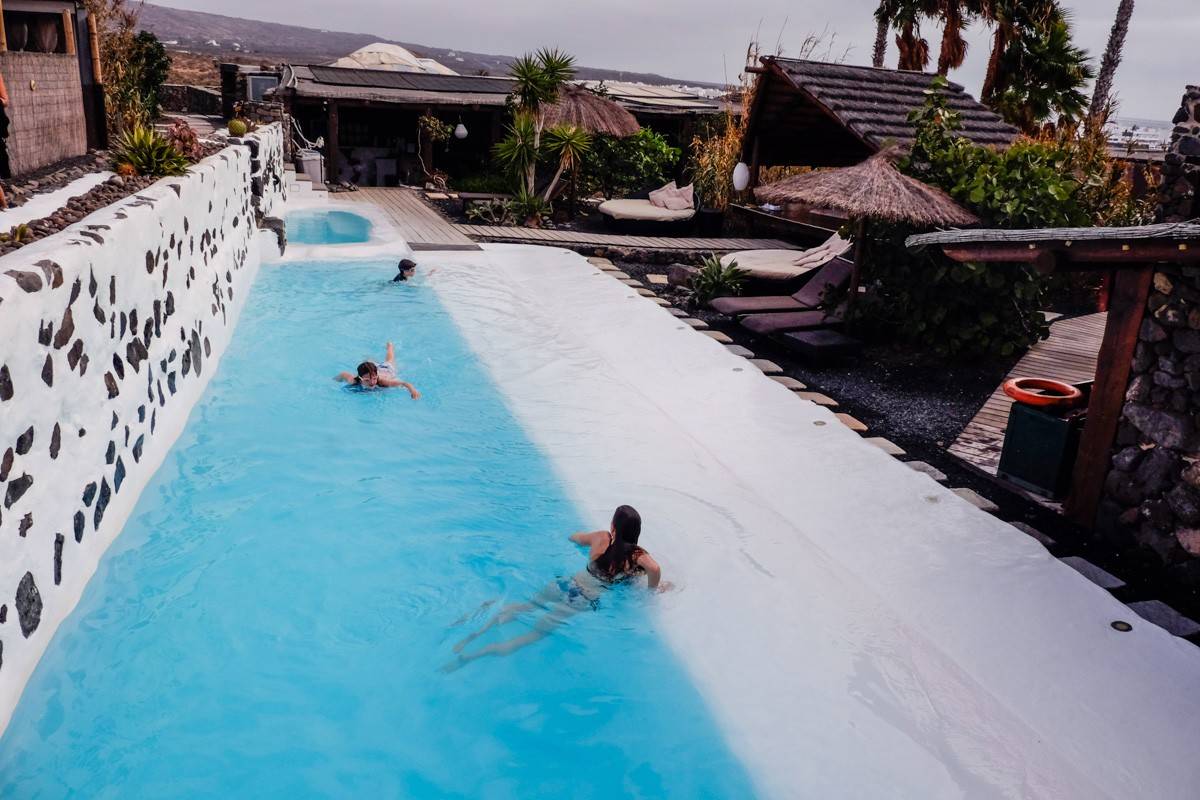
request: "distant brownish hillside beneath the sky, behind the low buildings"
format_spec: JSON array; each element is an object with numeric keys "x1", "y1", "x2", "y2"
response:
[{"x1": 140, "y1": 2, "x2": 714, "y2": 86}]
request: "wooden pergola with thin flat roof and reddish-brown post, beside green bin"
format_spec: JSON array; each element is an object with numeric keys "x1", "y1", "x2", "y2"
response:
[{"x1": 905, "y1": 223, "x2": 1200, "y2": 528}]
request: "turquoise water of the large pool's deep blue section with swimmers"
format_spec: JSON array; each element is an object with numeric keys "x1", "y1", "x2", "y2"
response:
[{"x1": 0, "y1": 260, "x2": 754, "y2": 800}]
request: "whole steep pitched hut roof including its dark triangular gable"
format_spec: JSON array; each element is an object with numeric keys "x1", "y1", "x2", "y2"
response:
[{"x1": 746, "y1": 56, "x2": 1019, "y2": 167}]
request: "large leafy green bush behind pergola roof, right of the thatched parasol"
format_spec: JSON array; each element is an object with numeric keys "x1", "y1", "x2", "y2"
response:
[{"x1": 854, "y1": 77, "x2": 1146, "y2": 357}]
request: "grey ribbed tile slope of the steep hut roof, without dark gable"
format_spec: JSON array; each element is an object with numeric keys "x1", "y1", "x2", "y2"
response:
[{"x1": 763, "y1": 56, "x2": 1019, "y2": 148}]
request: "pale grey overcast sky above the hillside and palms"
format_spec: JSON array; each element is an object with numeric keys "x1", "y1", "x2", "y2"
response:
[{"x1": 162, "y1": 0, "x2": 1200, "y2": 119}]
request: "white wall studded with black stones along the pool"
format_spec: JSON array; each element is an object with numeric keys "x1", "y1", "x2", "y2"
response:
[{"x1": 0, "y1": 126, "x2": 282, "y2": 733}]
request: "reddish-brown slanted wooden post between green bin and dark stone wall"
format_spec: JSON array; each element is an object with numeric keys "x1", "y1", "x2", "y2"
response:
[{"x1": 1064, "y1": 266, "x2": 1154, "y2": 528}]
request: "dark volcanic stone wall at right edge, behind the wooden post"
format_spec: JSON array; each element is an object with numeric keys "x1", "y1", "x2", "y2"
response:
[{"x1": 1098, "y1": 86, "x2": 1200, "y2": 584}]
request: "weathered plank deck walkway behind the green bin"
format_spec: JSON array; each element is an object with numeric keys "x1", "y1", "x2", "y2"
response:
[{"x1": 949, "y1": 313, "x2": 1108, "y2": 475}]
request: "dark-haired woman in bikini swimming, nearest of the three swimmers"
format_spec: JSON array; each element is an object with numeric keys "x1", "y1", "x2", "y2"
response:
[{"x1": 444, "y1": 506, "x2": 671, "y2": 672}]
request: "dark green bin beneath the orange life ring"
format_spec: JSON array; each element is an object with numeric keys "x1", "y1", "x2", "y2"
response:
[{"x1": 996, "y1": 381, "x2": 1092, "y2": 500}]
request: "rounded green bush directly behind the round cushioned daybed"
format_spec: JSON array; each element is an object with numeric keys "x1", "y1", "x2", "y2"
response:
[{"x1": 580, "y1": 128, "x2": 680, "y2": 198}]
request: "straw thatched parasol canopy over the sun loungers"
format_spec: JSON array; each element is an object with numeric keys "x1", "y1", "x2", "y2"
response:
[{"x1": 755, "y1": 150, "x2": 979, "y2": 228}]
